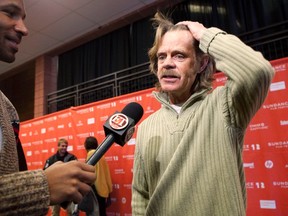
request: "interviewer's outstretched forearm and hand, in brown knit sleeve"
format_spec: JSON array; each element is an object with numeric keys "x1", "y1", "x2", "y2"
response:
[{"x1": 0, "y1": 161, "x2": 96, "y2": 216}]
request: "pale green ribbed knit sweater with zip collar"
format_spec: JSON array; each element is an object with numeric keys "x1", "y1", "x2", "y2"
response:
[{"x1": 132, "y1": 28, "x2": 274, "y2": 216}]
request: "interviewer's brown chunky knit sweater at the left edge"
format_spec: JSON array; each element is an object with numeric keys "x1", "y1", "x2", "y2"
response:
[{"x1": 0, "y1": 91, "x2": 50, "y2": 216}]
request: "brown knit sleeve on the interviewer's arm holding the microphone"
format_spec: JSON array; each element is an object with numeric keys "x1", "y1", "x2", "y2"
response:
[{"x1": 0, "y1": 170, "x2": 50, "y2": 216}]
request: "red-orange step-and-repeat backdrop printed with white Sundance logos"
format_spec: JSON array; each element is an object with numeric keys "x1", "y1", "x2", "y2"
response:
[{"x1": 20, "y1": 58, "x2": 288, "y2": 216}]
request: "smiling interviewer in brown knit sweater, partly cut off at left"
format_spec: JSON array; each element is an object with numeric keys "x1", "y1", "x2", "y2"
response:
[{"x1": 0, "y1": 0, "x2": 95, "y2": 216}]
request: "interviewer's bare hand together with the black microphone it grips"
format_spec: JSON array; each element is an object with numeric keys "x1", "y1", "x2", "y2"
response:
[{"x1": 44, "y1": 102, "x2": 143, "y2": 208}]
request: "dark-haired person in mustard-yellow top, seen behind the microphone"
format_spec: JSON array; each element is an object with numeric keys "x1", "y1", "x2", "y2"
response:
[{"x1": 84, "y1": 136, "x2": 112, "y2": 216}]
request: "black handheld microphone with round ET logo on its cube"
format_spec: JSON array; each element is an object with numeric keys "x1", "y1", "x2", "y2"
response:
[{"x1": 86, "y1": 102, "x2": 143, "y2": 166}]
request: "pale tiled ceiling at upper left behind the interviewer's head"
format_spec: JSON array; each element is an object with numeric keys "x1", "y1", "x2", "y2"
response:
[{"x1": 0, "y1": 0, "x2": 161, "y2": 75}]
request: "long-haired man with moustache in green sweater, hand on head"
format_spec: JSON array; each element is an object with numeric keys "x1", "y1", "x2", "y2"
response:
[{"x1": 132, "y1": 13, "x2": 274, "y2": 216}]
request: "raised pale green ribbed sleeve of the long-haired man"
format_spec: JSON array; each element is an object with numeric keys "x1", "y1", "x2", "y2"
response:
[{"x1": 200, "y1": 27, "x2": 274, "y2": 128}]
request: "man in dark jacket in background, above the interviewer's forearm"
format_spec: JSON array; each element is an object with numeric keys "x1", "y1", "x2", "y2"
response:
[{"x1": 43, "y1": 138, "x2": 77, "y2": 216}]
